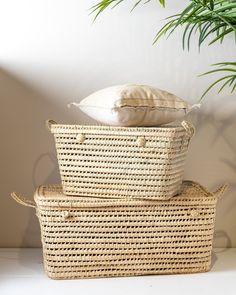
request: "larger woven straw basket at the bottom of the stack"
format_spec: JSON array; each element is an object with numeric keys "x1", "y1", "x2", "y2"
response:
[{"x1": 12, "y1": 182, "x2": 225, "y2": 279}]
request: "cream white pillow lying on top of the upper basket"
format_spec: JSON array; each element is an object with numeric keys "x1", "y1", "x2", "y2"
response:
[{"x1": 70, "y1": 84, "x2": 196, "y2": 126}]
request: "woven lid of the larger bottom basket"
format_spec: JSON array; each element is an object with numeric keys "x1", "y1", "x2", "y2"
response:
[{"x1": 34, "y1": 181, "x2": 225, "y2": 208}]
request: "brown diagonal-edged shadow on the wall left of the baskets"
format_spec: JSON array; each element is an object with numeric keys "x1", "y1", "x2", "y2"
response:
[{"x1": 0, "y1": 69, "x2": 70, "y2": 247}]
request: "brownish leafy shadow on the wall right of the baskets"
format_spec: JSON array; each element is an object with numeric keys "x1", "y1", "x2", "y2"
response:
[{"x1": 185, "y1": 95, "x2": 236, "y2": 247}]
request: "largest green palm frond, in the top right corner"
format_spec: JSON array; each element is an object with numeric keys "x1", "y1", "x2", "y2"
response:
[{"x1": 154, "y1": 0, "x2": 236, "y2": 49}]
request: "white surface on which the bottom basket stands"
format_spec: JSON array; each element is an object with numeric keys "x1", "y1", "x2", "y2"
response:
[{"x1": 0, "y1": 248, "x2": 236, "y2": 295}]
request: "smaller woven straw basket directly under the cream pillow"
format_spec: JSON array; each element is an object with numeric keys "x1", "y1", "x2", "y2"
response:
[{"x1": 48, "y1": 121, "x2": 194, "y2": 200}]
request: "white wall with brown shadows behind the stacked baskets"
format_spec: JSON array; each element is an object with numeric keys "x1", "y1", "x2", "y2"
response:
[{"x1": 0, "y1": 0, "x2": 236, "y2": 247}]
